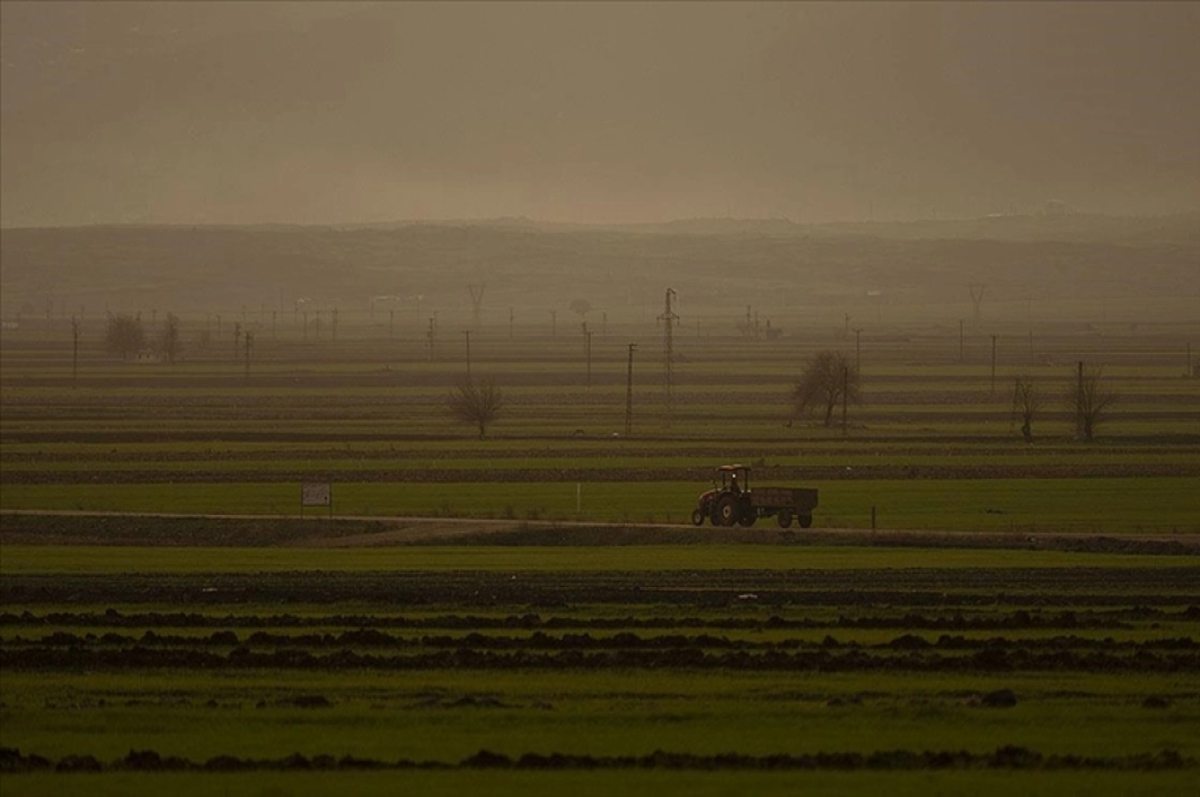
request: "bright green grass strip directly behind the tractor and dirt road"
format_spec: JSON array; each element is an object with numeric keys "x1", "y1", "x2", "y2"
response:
[{"x1": 0, "y1": 472, "x2": 1200, "y2": 533}]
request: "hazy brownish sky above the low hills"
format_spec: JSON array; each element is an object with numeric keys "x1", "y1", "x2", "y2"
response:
[{"x1": 0, "y1": 0, "x2": 1200, "y2": 227}]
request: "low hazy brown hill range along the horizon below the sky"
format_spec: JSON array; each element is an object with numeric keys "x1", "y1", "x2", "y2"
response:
[{"x1": 0, "y1": 214, "x2": 1200, "y2": 320}]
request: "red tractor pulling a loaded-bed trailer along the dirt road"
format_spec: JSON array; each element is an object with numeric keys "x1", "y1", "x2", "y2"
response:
[{"x1": 691, "y1": 465, "x2": 817, "y2": 528}]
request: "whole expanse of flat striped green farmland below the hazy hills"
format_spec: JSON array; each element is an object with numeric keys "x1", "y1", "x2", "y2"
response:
[{"x1": 0, "y1": 279, "x2": 1200, "y2": 797}]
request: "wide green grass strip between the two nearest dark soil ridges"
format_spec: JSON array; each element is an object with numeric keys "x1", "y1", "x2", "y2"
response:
[{"x1": 0, "y1": 671, "x2": 1200, "y2": 761}]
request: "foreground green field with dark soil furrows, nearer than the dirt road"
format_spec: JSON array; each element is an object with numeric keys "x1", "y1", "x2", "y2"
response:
[{"x1": 0, "y1": 545, "x2": 1200, "y2": 793}]
